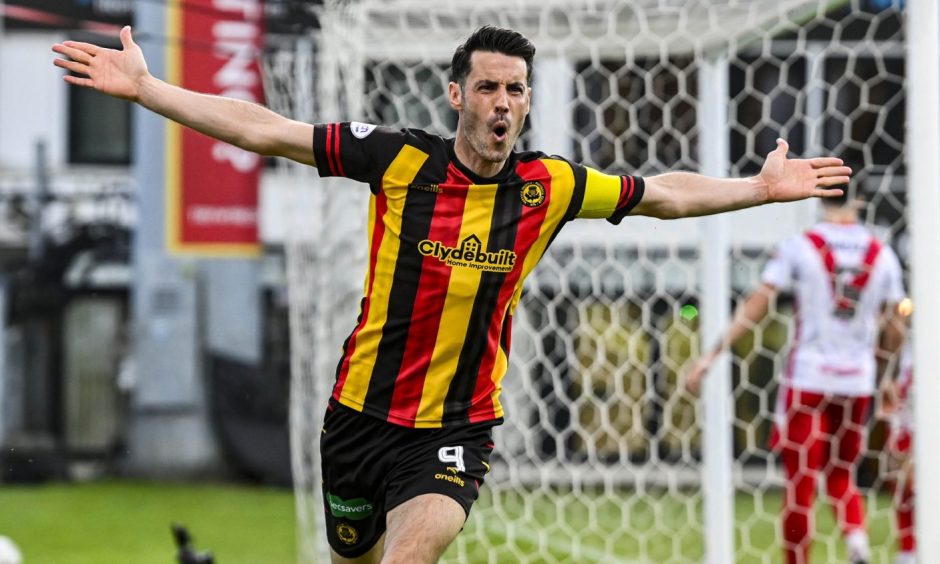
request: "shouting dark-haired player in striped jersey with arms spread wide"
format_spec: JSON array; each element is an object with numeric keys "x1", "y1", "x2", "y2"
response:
[{"x1": 53, "y1": 26, "x2": 851, "y2": 564}]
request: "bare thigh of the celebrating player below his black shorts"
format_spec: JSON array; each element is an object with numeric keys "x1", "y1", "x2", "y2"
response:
[{"x1": 383, "y1": 494, "x2": 466, "y2": 564}]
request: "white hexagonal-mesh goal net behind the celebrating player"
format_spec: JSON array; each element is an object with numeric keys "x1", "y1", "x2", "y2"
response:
[{"x1": 264, "y1": 0, "x2": 908, "y2": 563}]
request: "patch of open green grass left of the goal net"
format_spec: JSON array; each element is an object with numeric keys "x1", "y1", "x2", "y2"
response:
[{"x1": 0, "y1": 481, "x2": 295, "y2": 564}]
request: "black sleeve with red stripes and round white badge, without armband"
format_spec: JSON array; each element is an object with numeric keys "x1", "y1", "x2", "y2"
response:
[{"x1": 313, "y1": 121, "x2": 407, "y2": 184}]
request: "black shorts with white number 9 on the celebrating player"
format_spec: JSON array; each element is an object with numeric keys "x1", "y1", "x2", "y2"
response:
[{"x1": 320, "y1": 400, "x2": 501, "y2": 558}]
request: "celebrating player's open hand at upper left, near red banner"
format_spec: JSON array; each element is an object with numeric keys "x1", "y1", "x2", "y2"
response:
[{"x1": 52, "y1": 26, "x2": 150, "y2": 101}]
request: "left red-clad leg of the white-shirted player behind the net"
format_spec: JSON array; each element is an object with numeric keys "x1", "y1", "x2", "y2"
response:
[{"x1": 780, "y1": 389, "x2": 825, "y2": 564}]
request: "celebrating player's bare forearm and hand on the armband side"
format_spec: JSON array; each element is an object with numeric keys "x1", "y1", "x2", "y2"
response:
[{"x1": 631, "y1": 139, "x2": 852, "y2": 219}]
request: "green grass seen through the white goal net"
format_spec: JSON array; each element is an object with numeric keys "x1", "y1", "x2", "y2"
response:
[{"x1": 445, "y1": 489, "x2": 894, "y2": 564}]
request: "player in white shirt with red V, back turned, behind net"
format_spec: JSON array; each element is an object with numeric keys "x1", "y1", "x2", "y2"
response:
[{"x1": 686, "y1": 191, "x2": 904, "y2": 564}]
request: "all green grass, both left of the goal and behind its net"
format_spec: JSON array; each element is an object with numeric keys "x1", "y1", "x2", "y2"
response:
[{"x1": 0, "y1": 480, "x2": 894, "y2": 564}]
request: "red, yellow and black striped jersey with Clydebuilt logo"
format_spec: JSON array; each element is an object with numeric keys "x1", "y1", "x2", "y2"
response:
[{"x1": 313, "y1": 122, "x2": 644, "y2": 428}]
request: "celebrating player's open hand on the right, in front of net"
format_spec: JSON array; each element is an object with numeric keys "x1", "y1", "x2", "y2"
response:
[{"x1": 760, "y1": 139, "x2": 852, "y2": 202}]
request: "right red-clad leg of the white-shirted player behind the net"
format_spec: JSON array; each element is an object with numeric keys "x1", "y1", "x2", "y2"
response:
[{"x1": 823, "y1": 397, "x2": 871, "y2": 562}]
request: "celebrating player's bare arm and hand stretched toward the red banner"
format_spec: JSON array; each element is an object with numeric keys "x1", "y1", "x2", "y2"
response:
[{"x1": 52, "y1": 26, "x2": 316, "y2": 165}]
